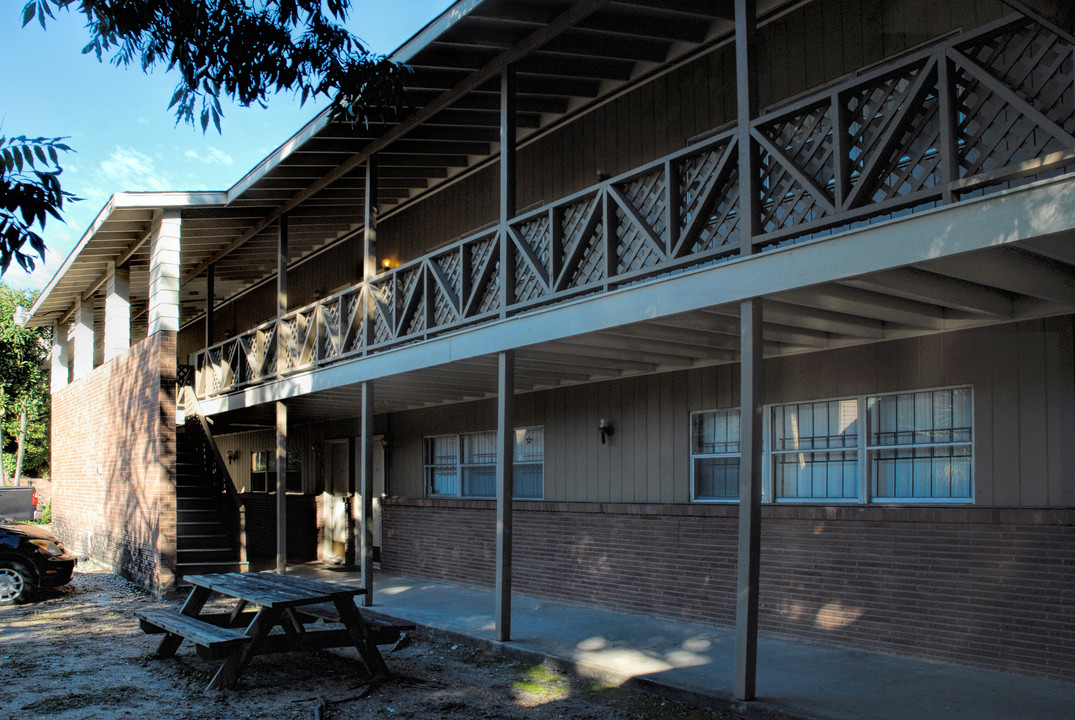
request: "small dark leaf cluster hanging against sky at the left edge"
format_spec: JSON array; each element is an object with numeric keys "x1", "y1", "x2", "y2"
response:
[{"x1": 0, "y1": 135, "x2": 77, "y2": 275}]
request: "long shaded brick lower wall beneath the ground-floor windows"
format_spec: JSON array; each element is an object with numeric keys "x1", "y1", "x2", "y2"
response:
[{"x1": 382, "y1": 500, "x2": 1075, "y2": 680}]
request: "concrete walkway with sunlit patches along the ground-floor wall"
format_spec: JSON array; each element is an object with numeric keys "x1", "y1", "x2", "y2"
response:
[{"x1": 293, "y1": 566, "x2": 1075, "y2": 720}]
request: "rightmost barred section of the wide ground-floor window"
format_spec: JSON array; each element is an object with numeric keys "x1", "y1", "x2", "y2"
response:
[{"x1": 866, "y1": 388, "x2": 974, "y2": 502}]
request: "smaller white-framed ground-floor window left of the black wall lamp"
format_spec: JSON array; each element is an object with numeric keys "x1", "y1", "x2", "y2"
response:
[{"x1": 425, "y1": 428, "x2": 545, "y2": 500}]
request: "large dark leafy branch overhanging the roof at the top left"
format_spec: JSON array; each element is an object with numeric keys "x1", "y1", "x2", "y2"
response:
[{"x1": 23, "y1": 0, "x2": 409, "y2": 131}]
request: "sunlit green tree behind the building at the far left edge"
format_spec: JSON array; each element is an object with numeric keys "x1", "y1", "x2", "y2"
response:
[{"x1": 0, "y1": 285, "x2": 52, "y2": 476}]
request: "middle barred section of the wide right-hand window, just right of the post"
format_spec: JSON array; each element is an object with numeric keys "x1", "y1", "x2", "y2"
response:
[{"x1": 770, "y1": 399, "x2": 860, "y2": 501}]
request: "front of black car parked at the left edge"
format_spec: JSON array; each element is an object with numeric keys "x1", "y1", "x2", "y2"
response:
[{"x1": 0, "y1": 519, "x2": 78, "y2": 605}]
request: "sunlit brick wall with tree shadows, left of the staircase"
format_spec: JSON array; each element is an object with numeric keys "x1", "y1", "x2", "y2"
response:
[{"x1": 52, "y1": 332, "x2": 175, "y2": 590}]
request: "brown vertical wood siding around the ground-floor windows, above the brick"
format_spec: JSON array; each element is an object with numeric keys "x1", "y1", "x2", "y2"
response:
[{"x1": 389, "y1": 316, "x2": 1075, "y2": 507}]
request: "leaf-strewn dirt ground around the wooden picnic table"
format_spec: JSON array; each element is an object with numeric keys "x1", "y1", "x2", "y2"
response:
[{"x1": 0, "y1": 563, "x2": 721, "y2": 720}]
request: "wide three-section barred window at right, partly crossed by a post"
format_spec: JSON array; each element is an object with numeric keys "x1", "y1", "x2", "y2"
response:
[{"x1": 690, "y1": 387, "x2": 974, "y2": 503}]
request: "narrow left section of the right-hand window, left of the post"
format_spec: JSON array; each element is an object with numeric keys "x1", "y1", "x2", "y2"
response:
[{"x1": 690, "y1": 409, "x2": 740, "y2": 501}]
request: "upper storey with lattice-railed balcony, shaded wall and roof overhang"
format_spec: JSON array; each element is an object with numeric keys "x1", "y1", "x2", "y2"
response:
[{"x1": 25, "y1": 0, "x2": 1075, "y2": 413}]
